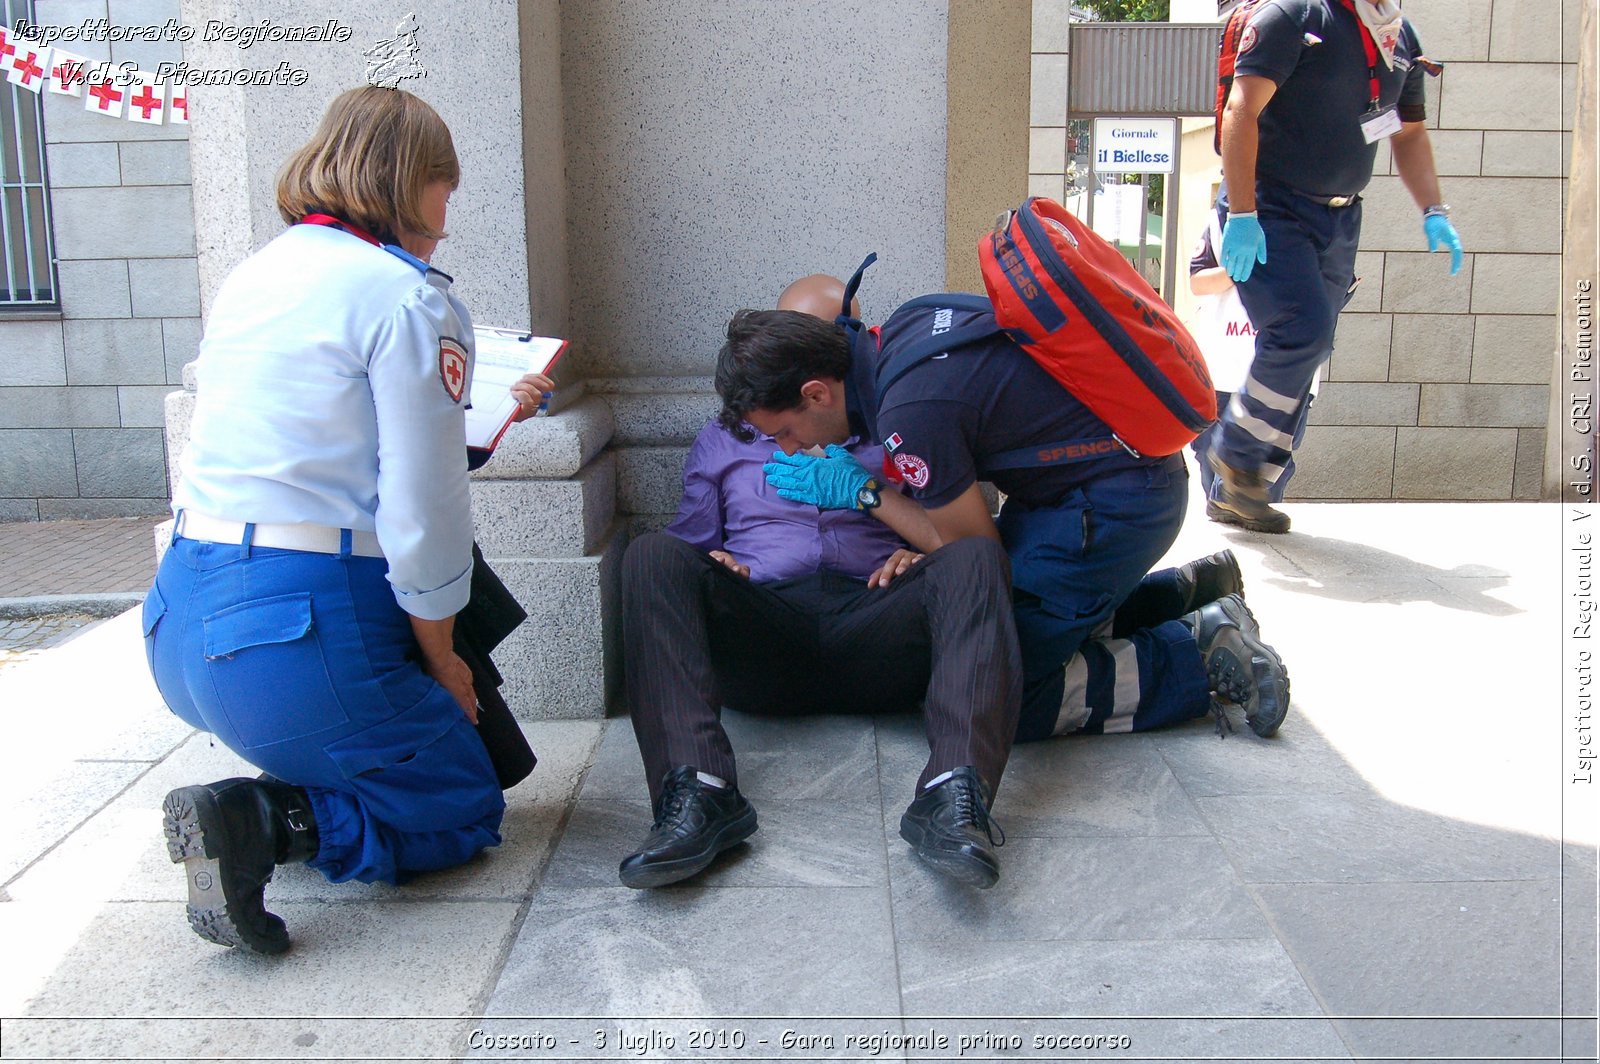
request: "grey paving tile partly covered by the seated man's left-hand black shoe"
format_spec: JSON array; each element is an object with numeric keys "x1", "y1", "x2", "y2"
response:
[{"x1": 546, "y1": 798, "x2": 888, "y2": 886}]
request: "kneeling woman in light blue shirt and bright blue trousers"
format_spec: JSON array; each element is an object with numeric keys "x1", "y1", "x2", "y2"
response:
[{"x1": 144, "y1": 88, "x2": 518, "y2": 954}]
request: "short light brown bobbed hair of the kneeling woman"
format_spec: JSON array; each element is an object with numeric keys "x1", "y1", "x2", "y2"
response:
[{"x1": 278, "y1": 85, "x2": 461, "y2": 243}]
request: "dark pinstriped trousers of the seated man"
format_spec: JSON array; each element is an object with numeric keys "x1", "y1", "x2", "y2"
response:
[{"x1": 622, "y1": 533, "x2": 1019, "y2": 800}]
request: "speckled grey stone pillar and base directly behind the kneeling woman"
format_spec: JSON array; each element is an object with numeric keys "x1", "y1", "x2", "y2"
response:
[{"x1": 166, "y1": 0, "x2": 624, "y2": 718}]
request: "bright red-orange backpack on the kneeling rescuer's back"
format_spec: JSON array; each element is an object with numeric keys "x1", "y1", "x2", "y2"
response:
[{"x1": 978, "y1": 197, "x2": 1216, "y2": 456}]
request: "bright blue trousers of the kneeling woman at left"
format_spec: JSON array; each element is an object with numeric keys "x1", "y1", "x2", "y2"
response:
[{"x1": 144, "y1": 539, "x2": 506, "y2": 883}]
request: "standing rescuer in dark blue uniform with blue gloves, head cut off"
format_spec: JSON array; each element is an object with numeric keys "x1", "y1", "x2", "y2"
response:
[{"x1": 1208, "y1": 0, "x2": 1461, "y2": 533}]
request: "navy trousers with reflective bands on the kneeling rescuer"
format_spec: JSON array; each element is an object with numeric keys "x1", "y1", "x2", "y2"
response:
[{"x1": 1000, "y1": 454, "x2": 1211, "y2": 742}]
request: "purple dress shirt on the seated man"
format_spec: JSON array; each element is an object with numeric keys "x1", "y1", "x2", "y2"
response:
[{"x1": 667, "y1": 421, "x2": 906, "y2": 584}]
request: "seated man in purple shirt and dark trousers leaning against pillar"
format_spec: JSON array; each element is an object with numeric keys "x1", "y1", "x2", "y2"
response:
[{"x1": 619, "y1": 278, "x2": 1021, "y2": 888}]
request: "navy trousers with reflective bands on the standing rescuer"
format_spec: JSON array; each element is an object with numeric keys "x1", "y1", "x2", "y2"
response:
[{"x1": 1214, "y1": 182, "x2": 1362, "y2": 483}]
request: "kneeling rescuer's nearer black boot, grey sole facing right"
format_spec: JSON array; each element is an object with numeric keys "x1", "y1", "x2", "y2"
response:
[{"x1": 1182, "y1": 595, "x2": 1290, "y2": 738}]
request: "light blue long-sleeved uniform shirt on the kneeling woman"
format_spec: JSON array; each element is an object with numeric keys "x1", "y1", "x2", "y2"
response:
[{"x1": 173, "y1": 226, "x2": 474, "y2": 621}]
